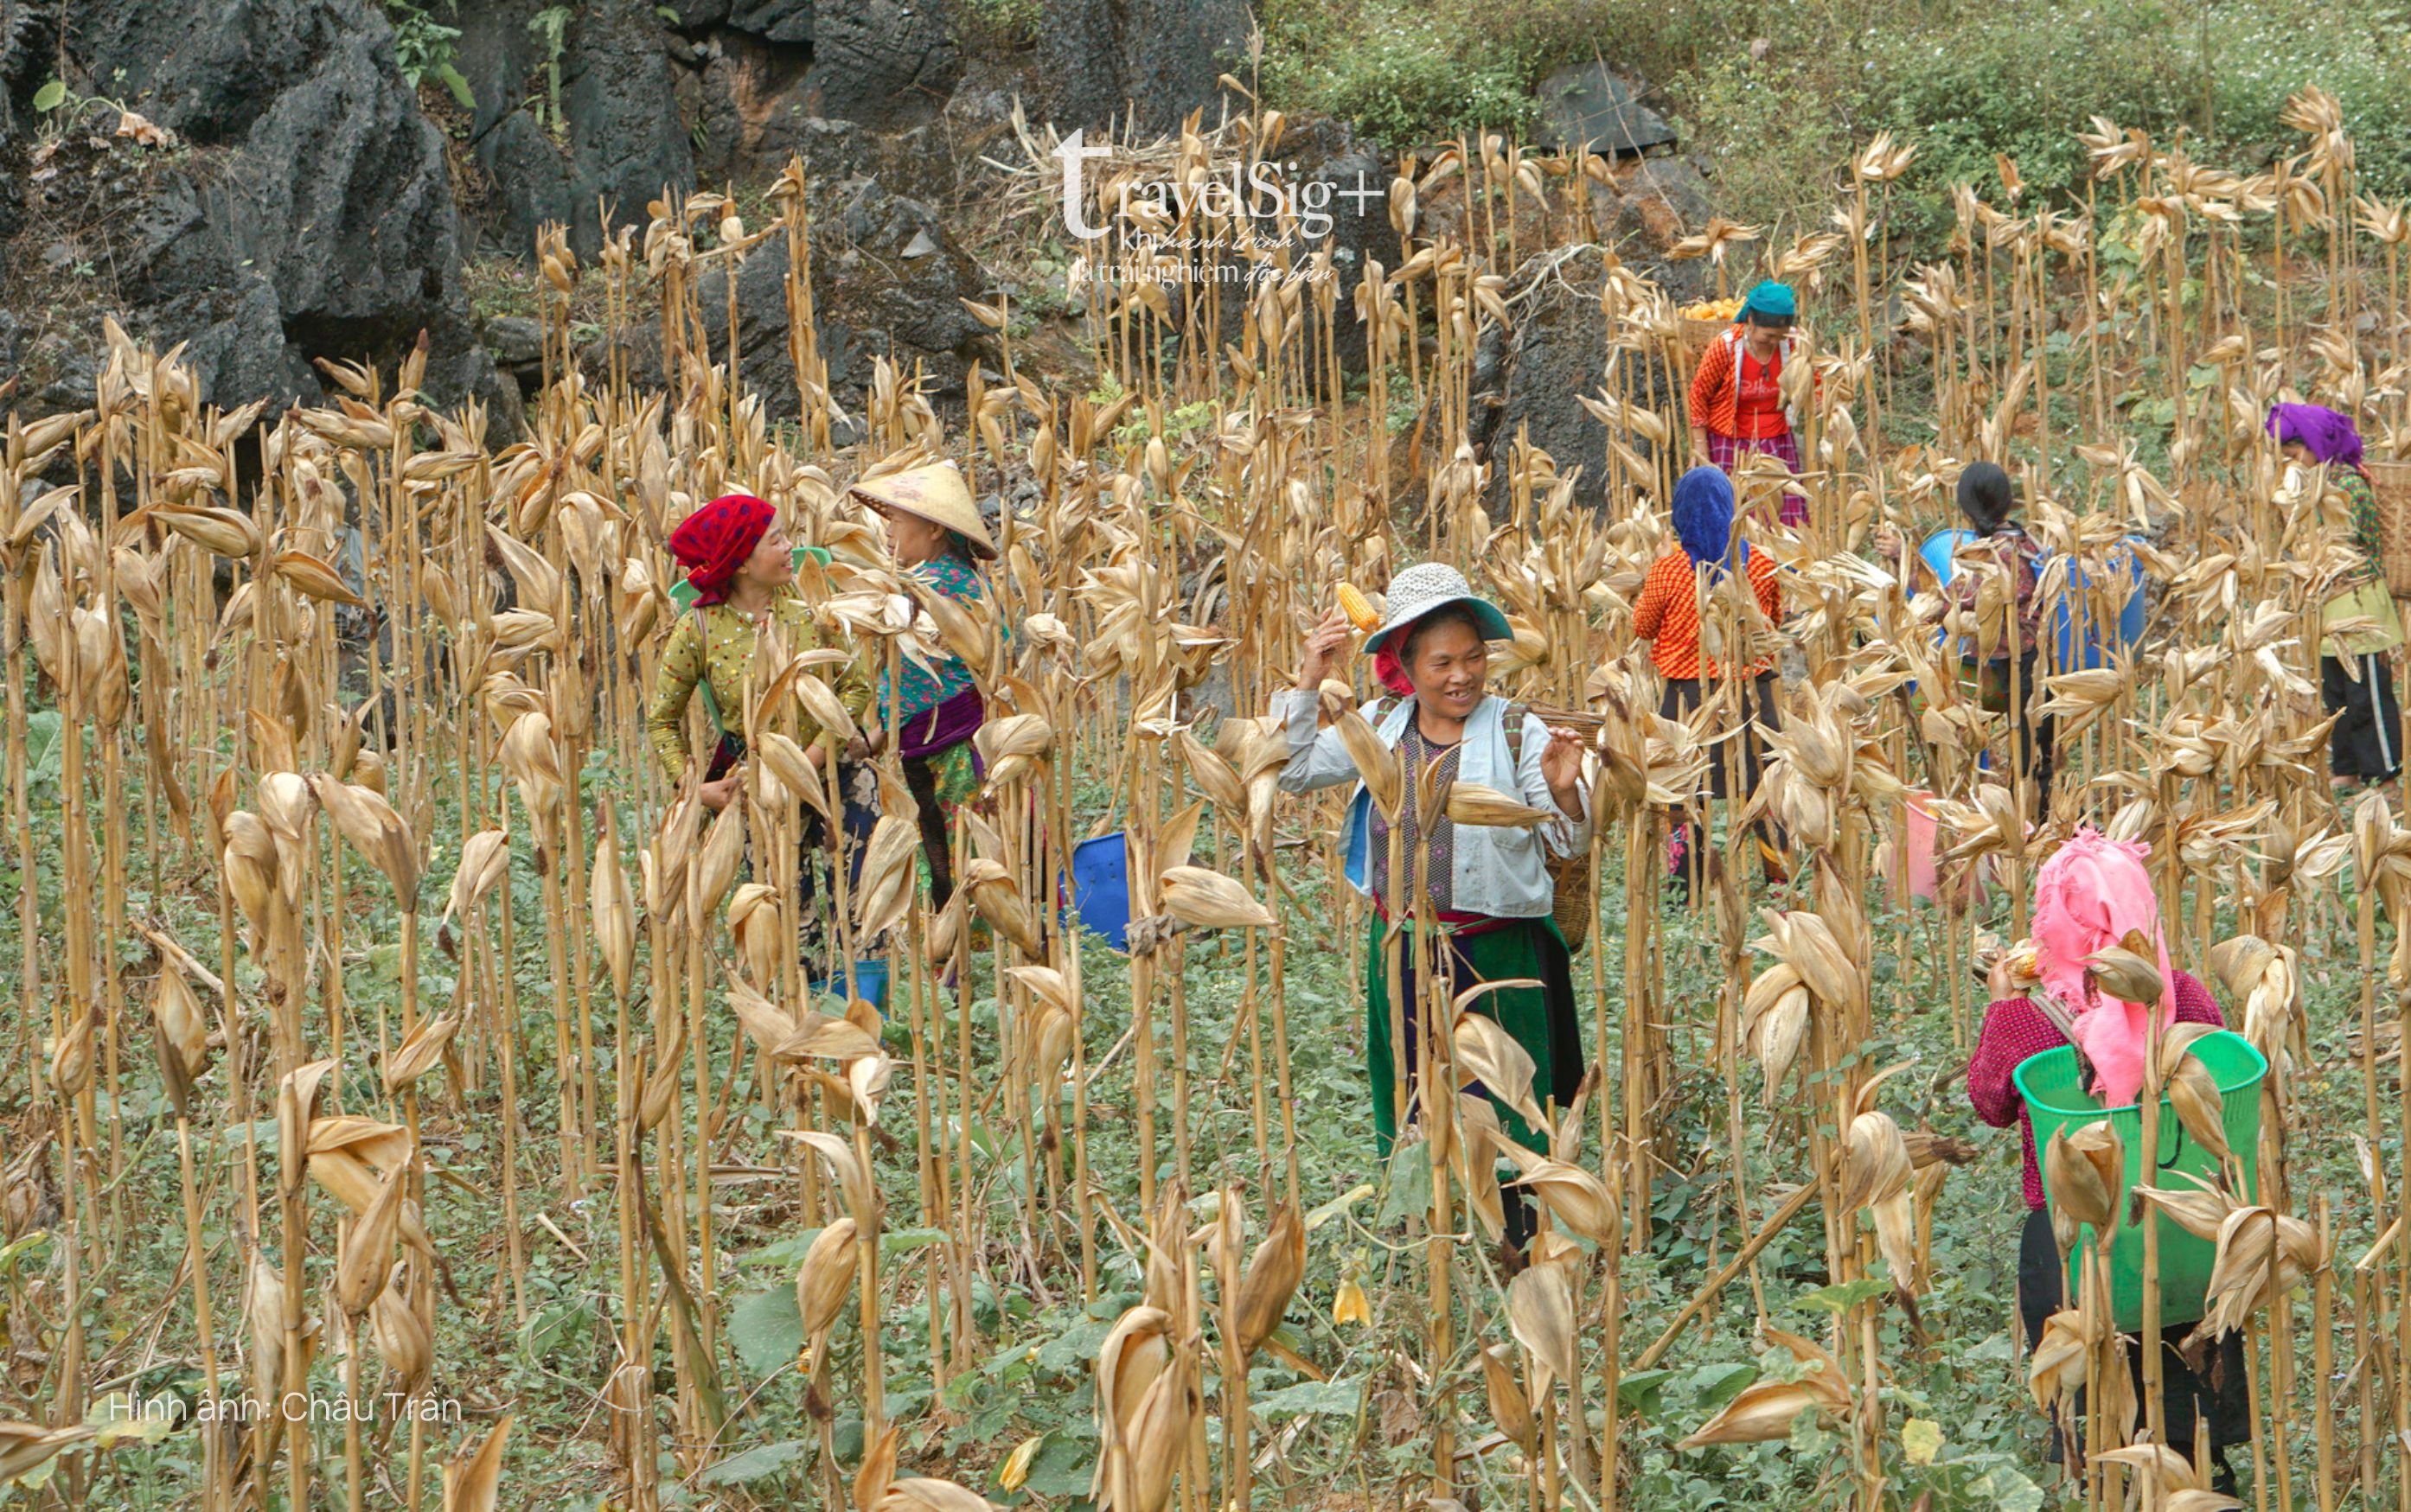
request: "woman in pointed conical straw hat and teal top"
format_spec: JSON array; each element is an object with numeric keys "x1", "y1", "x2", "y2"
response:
[{"x1": 851, "y1": 463, "x2": 995, "y2": 904}]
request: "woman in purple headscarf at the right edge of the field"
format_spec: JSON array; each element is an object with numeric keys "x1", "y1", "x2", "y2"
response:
[{"x1": 2269, "y1": 405, "x2": 2404, "y2": 791}]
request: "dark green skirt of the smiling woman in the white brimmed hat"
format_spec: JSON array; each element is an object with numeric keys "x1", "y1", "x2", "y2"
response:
[{"x1": 1365, "y1": 914, "x2": 1582, "y2": 1160}]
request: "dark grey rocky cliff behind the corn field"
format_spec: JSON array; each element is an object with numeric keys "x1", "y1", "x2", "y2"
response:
[{"x1": 0, "y1": 0, "x2": 1707, "y2": 482}]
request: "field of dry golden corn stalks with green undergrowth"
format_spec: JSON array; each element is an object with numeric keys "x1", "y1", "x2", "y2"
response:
[{"x1": 0, "y1": 89, "x2": 2411, "y2": 1512}]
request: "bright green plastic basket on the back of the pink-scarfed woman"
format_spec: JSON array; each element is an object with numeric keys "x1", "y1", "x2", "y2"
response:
[{"x1": 2011, "y1": 1030, "x2": 2269, "y2": 1334}]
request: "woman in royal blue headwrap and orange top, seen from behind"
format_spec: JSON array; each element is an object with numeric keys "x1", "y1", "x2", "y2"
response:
[{"x1": 1632, "y1": 468, "x2": 1784, "y2": 895}]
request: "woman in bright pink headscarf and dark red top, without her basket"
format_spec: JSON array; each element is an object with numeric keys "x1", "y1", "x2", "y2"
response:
[{"x1": 1967, "y1": 830, "x2": 2252, "y2": 1490}]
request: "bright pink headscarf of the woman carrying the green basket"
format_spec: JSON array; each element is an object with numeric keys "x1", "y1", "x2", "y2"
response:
[{"x1": 2035, "y1": 827, "x2": 2178, "y2": 1107}]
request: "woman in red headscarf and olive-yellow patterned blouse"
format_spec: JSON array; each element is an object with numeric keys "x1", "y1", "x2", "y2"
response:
[{"x1": 643, "y1": 494, "x2": 870, "y2": 807}]
